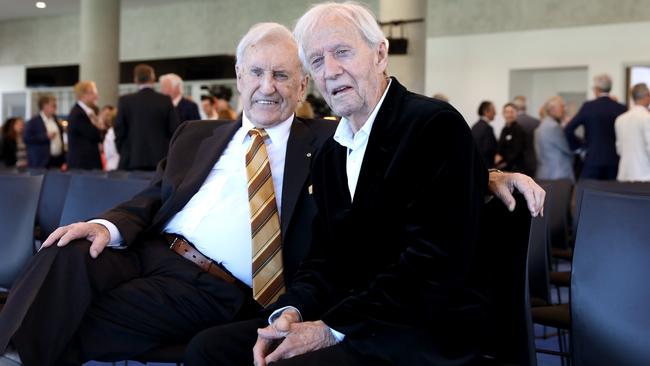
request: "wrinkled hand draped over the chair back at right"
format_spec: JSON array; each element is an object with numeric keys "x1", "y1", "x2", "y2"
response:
[{"x1": 488, "y1": 171, "x2": 546, "y2": 217}]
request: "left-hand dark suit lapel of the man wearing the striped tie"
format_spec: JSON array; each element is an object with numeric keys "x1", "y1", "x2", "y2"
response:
[{"x1": 163, "y1": 121, "x2": 241, "y2": 221}]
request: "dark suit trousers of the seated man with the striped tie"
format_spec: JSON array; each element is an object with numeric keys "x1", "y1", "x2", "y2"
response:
[{"x1": 0, "y1": 238, "x2": 253, "y2": 366}]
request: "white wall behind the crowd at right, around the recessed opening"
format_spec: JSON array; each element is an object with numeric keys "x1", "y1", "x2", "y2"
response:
[{"x1": 426, "y1": 22, "x2": 650, "y2": 134}]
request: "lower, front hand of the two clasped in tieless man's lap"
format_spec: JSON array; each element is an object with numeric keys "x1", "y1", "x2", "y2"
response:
[{"x1": 254, "y1": 320, "x2": 337, "y2": 366}]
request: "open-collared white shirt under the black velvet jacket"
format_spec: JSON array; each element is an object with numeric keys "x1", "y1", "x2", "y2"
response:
[{"x1": 334, "y1": 79, "x2": 392, "y2": 200}]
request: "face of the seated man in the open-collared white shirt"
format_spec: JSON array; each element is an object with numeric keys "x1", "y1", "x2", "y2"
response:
[{"x1": 304, "y1": 16, "x2": 388, "y2": 124}]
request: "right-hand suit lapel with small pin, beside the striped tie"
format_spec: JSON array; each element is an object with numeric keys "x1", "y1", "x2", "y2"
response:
[{"x1": 280, "y1": 118, "x2": 315, "y2": 233}]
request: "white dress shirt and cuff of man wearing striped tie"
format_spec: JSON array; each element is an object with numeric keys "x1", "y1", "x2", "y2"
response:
[{"x1": 91, "y1": 114, "x2": 293, "y2": 286}]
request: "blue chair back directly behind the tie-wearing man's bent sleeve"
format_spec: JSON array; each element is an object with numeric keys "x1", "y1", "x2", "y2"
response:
[{"x1": 59, "y1": 175, "x2": 148, "y2": 225}]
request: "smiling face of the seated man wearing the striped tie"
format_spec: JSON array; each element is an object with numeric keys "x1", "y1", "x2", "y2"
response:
[{"x1": 235, "y1": 36, "x2": 307, "y2": 128}]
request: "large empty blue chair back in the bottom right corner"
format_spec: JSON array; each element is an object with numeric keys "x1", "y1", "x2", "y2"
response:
[{"x1": 571, "y1": 190, "x2": 650, "y2": 366}]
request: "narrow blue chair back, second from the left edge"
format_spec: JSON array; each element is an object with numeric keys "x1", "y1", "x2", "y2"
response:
[{"x1": 36, "y1": 171, "x2": 71, "y2": 240}]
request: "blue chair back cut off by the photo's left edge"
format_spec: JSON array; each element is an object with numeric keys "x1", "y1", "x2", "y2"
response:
[{"x1": 0, "y1": 175, "x2": 43, "y2": 289}]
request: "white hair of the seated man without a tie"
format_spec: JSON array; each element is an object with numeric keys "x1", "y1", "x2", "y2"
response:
[{"x1": 293, "y1": 1, "x2": 388, "y2": 70}]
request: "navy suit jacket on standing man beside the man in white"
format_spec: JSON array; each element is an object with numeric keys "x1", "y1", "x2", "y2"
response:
[{"x1": 564, "y1": 96, "x2": 626, "y2": 166}]
